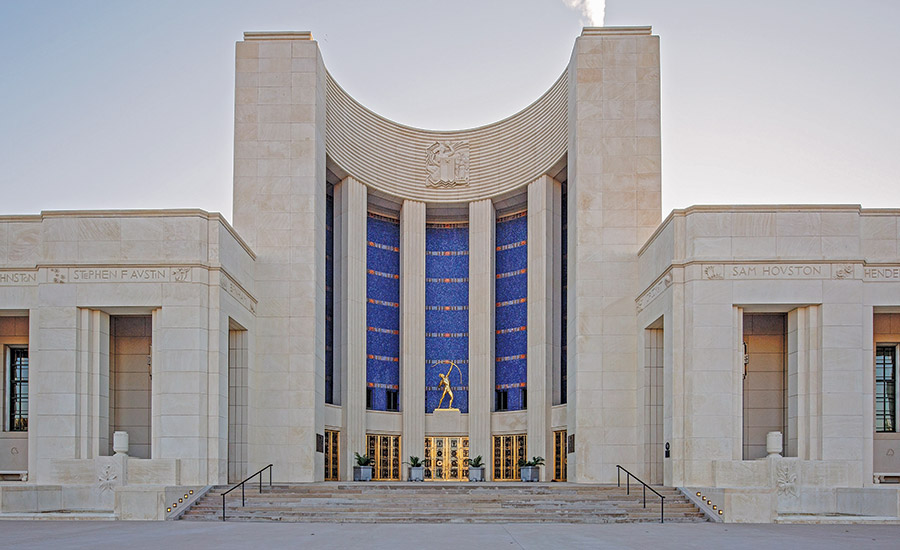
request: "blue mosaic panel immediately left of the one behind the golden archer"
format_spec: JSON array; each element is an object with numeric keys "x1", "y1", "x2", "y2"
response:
[{"x1": 366, "y1": 212, "x2": 400, "y2": 411}]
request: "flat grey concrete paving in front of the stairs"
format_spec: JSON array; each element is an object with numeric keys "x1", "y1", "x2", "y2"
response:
[{"x1": 0, "y1": 521, "x2": 900, "y2": 550}]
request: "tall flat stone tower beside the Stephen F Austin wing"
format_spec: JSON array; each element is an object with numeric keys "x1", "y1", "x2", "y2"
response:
[{"x1": 234, "y1": 32, "x2": 326, "y2": 482}]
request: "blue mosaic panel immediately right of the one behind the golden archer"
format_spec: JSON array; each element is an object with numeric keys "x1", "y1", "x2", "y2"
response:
[{"x1": 494, "y1": 212, "x2": 528, "y2": 411}]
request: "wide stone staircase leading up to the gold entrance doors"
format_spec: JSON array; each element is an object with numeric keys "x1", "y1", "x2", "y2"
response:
[{"x1": 181, "y1": 482, "x2": 706, "y2": 523}]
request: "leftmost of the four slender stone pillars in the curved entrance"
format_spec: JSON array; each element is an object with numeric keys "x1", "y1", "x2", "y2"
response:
[{"x1": 334, "y1": 178, "x2": 367, "y2": 479}]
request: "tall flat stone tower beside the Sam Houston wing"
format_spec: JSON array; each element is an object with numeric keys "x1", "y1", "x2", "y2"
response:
[{"x1": 568, "y1": 27, "x2": 662, "y2": 483}]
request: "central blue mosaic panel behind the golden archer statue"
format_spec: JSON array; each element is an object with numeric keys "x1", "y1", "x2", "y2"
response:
[{"x1": 425, "y1": 223, "x2": 469, "y2": 413}]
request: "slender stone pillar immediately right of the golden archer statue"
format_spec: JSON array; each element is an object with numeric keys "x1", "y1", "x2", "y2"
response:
[{"x1": 469, "y1": 199, "x2": 496, "y2": 479}]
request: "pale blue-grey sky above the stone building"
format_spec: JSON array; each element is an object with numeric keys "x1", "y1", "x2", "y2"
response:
[{"x1": 0, "y1": 0, "x2": 900, "y2": 223}]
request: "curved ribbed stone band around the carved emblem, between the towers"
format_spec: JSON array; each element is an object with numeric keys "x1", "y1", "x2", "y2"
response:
[{"x1": 325, "y1": 73, "x2": 569, "y2": 203}]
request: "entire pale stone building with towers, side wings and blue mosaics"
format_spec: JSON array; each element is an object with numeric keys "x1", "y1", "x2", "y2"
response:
[{"x1": 0, "y1": 27, "x2": 900, "y2": 521}]
